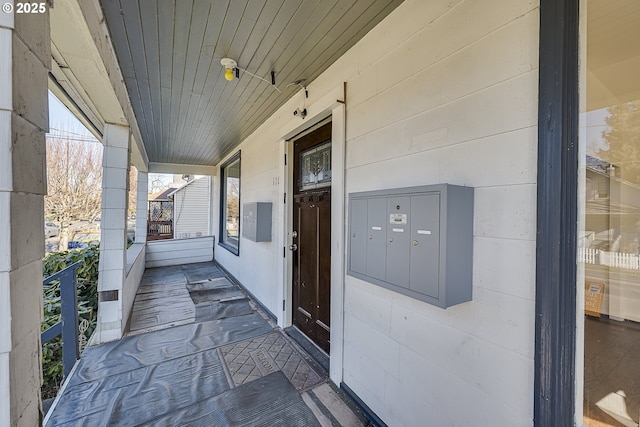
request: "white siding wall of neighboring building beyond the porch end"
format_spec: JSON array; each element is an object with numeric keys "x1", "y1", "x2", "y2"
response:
[{"x1": 173, "y1": 177, "x2": 211, "y2": 239}]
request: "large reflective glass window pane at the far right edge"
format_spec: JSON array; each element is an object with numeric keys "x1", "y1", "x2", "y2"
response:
[{"x1": 578, "y1": 0, "x2": 640, "y2": 427}]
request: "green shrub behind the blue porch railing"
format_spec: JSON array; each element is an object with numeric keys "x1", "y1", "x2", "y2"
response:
[{"x1": 41, "y1": 245, "x2": 100, "y2": 399}]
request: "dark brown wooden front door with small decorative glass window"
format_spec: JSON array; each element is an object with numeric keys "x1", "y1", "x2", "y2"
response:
[{"x1": 293, "y1": 123, "x2": 331, "y2": 353}]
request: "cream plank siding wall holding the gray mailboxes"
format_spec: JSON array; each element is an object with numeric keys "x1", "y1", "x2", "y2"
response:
[{"x1": 214, "y1": 0, "x2": 539, "y2": 426}]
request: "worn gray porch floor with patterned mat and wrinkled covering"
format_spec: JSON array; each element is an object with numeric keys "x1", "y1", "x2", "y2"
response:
[{"x1": 45, "y1": 263, "x2": 367, "y2": 427}]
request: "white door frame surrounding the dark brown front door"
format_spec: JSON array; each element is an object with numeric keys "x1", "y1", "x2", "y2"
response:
[{"x1": 278, "y1": 83, "x2": 346, "y2": 385}]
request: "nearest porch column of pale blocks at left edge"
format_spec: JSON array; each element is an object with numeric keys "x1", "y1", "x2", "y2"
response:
[{"x1": 0, "y1": 2, "x2": 51, "y2": 426}]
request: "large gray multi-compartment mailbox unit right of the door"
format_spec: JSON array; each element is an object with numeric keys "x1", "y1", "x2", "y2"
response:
[{"x1": 347, "y1": 184, "x2": 473, "y2": 308}]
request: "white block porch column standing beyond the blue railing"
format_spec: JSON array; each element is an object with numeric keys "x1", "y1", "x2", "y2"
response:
[{"x1": 96, "y1": 124, "x2": 130, "y2": 343}]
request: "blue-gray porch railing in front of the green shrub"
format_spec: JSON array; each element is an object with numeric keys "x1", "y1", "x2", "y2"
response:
[{"x1": 40, "y1": 261, "x2": 82, "y2": 377}]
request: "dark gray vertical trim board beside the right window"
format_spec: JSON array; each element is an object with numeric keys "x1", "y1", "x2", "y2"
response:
[{"x1": 533, "y1": 0, "x2": 579, "y2": 427}]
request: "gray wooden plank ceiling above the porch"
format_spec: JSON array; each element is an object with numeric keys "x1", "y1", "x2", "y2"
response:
[{"x1": 100, "y1": 0, "x2": 402, "y2": 165}]
